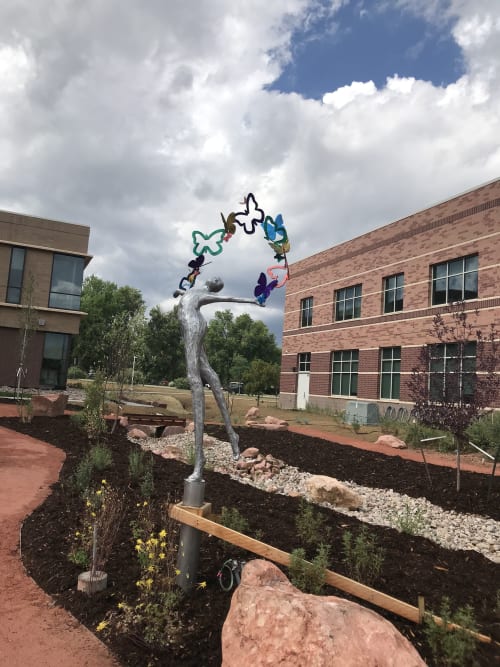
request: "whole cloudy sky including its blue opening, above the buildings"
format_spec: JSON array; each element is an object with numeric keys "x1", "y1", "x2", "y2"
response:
[{"x1": 0, "y1": 0, "x2": 500, "y2": 340}]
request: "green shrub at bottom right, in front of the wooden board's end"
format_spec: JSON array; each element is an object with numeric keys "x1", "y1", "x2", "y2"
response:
[{"x1": 424, "y1": 597, "x2": 477, "y2": 667}]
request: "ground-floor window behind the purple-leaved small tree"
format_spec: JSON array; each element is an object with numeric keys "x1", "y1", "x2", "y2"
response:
[{"x1": 429, "y1": 341, "x2": 476, "y2": 403}]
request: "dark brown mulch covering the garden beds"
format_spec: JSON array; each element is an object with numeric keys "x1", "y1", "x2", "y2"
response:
[{"x1": 4, "y1": 417, "x2": 500, "y2": 667}]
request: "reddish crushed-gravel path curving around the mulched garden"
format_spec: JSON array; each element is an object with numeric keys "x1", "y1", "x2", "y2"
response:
[{"x1": 0, "y1": 404, "x2": 500, "y2": 667}]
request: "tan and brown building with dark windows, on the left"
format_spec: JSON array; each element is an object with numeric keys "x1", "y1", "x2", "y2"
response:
[{"x1": 0, "y1": 211, "x2": 91, "y2": 388}]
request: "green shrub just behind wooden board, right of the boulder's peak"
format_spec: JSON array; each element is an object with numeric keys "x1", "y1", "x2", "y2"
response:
[{"x1": 342, "y1": 527, "x2": 384, "y2": 586}]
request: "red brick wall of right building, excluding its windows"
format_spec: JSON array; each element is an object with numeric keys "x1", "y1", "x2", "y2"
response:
[{"x1": 281, "y1": 180, "x2": 500, "y2": 407}]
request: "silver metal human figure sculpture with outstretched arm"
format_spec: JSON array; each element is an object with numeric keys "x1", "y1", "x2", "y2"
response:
[{"x1": 174, "y1": 278, "x2": 261, "y2": 482}]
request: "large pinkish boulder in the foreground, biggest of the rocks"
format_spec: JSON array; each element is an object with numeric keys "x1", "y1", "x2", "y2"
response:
[{"x1": 222, "y1": 560, "x2": 425, "y2": 667}]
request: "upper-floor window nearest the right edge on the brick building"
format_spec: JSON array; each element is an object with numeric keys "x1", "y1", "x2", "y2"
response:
[{"x1": 432, "y1": 255, "x2": 478, "y2": 306}]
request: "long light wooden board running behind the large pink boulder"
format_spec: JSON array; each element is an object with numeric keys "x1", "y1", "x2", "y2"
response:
[{"x1": 169, "y1": 504, "x2": 497, "y2": 644}]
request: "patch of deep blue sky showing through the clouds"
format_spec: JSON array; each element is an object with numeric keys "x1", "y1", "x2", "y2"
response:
[{"x1": 270, "y1": 2, "x2": 464, "y2": 99}]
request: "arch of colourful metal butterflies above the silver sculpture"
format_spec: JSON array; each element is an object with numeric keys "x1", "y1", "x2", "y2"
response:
[{"x1": 179, "y1": 193, "x2": 290, "y2": 305}]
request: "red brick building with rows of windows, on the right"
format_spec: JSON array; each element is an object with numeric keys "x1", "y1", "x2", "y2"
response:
[{"x1": 280, "y1": 179, "x2": 500, "y2": 414}]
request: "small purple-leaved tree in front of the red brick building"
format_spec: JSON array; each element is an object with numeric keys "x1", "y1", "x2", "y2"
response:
[{"x1": 409, "y1": 301, "x2": 500, "y2": 491}]
